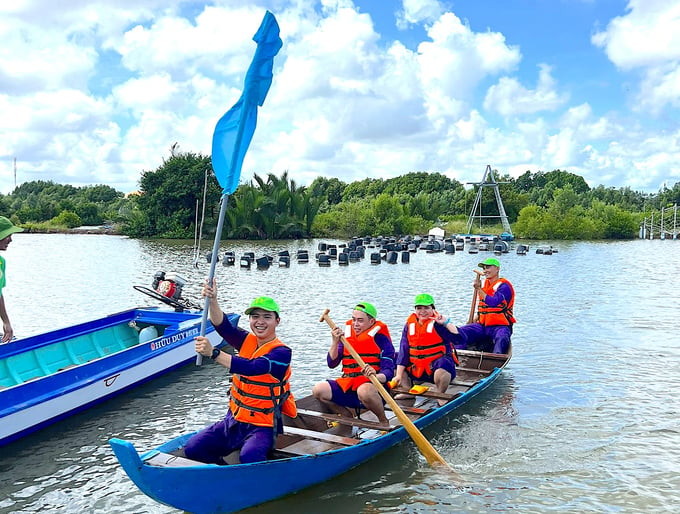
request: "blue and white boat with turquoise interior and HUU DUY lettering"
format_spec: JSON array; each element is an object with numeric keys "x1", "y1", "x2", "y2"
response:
[{"x1": 0, "y1": 308, "x2": 234, "y2": 446}]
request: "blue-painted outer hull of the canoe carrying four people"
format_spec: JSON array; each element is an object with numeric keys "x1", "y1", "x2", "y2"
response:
[{"x1": 110, "y1": 352, "x2": 509, "y2": 514}]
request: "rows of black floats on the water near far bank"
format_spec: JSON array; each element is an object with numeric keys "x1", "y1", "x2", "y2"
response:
[{"x1": 206, "y1": 238, "x2": 557, "y2": 269}]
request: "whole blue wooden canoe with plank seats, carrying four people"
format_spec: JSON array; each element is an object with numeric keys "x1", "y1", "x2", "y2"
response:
[{"x1": 110, "y1": 350, "x2": 510, "y2": 514}]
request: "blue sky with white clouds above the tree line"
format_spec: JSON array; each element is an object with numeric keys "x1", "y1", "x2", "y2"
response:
[{"x1": 0, "y1": 0, "x2": 680, "y2": 194}]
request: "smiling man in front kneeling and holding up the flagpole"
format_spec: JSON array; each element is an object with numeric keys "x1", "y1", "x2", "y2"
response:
[{"x1": 184, "y1": 284, "x2": 297, "y2": 464}]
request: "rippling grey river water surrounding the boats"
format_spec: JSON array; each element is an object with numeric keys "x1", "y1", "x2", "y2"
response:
[{"x1": 0, "y1": 234, "x2": 680, "y2": 514}]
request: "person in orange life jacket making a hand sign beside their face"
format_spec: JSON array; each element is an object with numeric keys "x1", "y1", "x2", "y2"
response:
[{"x1": 394, "y1": 294, "x2": 458, "y2": 400}]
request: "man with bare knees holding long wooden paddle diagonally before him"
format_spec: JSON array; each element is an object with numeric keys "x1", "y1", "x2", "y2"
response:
[{"x1": 312, "y1": 302, "x2": 395, "y2": 425}]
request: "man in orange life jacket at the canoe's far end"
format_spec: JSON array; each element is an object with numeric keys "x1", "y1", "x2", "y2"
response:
[{"x1": 455, "y1": 257, "x2": 515, "y2": 353}]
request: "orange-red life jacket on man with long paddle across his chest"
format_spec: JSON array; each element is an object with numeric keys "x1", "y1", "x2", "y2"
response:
[{"x1": 336, "y1": 320, "x2": 390, "y2": 392}]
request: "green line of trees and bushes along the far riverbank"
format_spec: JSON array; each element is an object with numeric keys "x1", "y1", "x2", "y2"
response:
[{"x1": 0, "y1": 153, "x2": 680, "y2": 239}]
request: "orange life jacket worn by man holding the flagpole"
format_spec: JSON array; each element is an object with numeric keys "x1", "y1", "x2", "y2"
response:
[{"x1": 229, "y1": 334, "x2": 297, "y2": 427}]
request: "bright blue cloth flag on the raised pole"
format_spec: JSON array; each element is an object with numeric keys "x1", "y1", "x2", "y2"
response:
[{"x1": 212, "y1": 11, "x2": 283, "y2": 194}]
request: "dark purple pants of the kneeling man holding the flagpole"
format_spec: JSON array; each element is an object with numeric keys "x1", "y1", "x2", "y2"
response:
[{"x1": 184, "y1": 411, "x2": 274, "y2": 464}]
